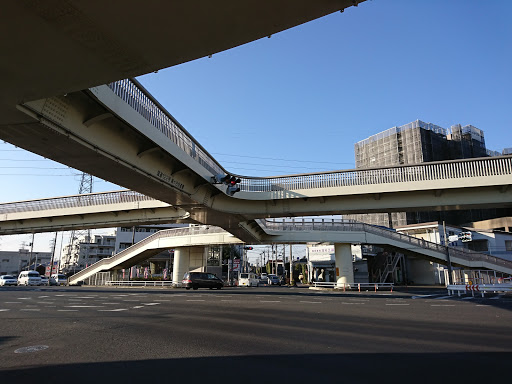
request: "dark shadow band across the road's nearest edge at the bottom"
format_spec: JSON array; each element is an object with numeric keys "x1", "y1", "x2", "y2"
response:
[{"x1": 1, "y1": 352, "x2": 512, "y2": 384}]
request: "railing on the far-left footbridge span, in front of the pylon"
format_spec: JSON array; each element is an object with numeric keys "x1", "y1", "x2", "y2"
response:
[{"x1": 0, "y1": 190, "x2": 155, "y2": 214}]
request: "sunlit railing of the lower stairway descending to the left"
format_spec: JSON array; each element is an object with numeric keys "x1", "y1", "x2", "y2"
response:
[{"x1": 71, "y1": 225, "x2": 225, "y2": 281}]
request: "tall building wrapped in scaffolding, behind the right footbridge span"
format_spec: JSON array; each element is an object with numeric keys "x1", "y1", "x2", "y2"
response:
[{"x1": 344, "y1": 120, "x2": 512, "y2": 228}]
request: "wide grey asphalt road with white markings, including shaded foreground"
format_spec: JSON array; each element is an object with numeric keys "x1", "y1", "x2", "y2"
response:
[{"x1": 0, "y1": 287, "x2": 512, "y2": 384}]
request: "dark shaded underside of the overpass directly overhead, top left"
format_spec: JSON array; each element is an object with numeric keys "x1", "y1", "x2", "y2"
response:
[{"x1": 0, "y1": 0, "x2": 364, "y2": 125}]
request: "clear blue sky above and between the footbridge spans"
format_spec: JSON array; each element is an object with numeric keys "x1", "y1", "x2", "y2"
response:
[{"x1": 0, "y1": 0, "x2": 512, "y2": 250}]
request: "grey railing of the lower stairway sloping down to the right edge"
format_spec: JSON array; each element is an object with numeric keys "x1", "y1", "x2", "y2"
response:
[{"x1": 256, "y1": 219, "x2": 512, "y2": 269}]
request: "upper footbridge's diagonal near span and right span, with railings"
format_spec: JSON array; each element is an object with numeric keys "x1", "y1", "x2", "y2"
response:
[{"x1": 0, "y1": 79, "x2": 512, "y2": 241}]
